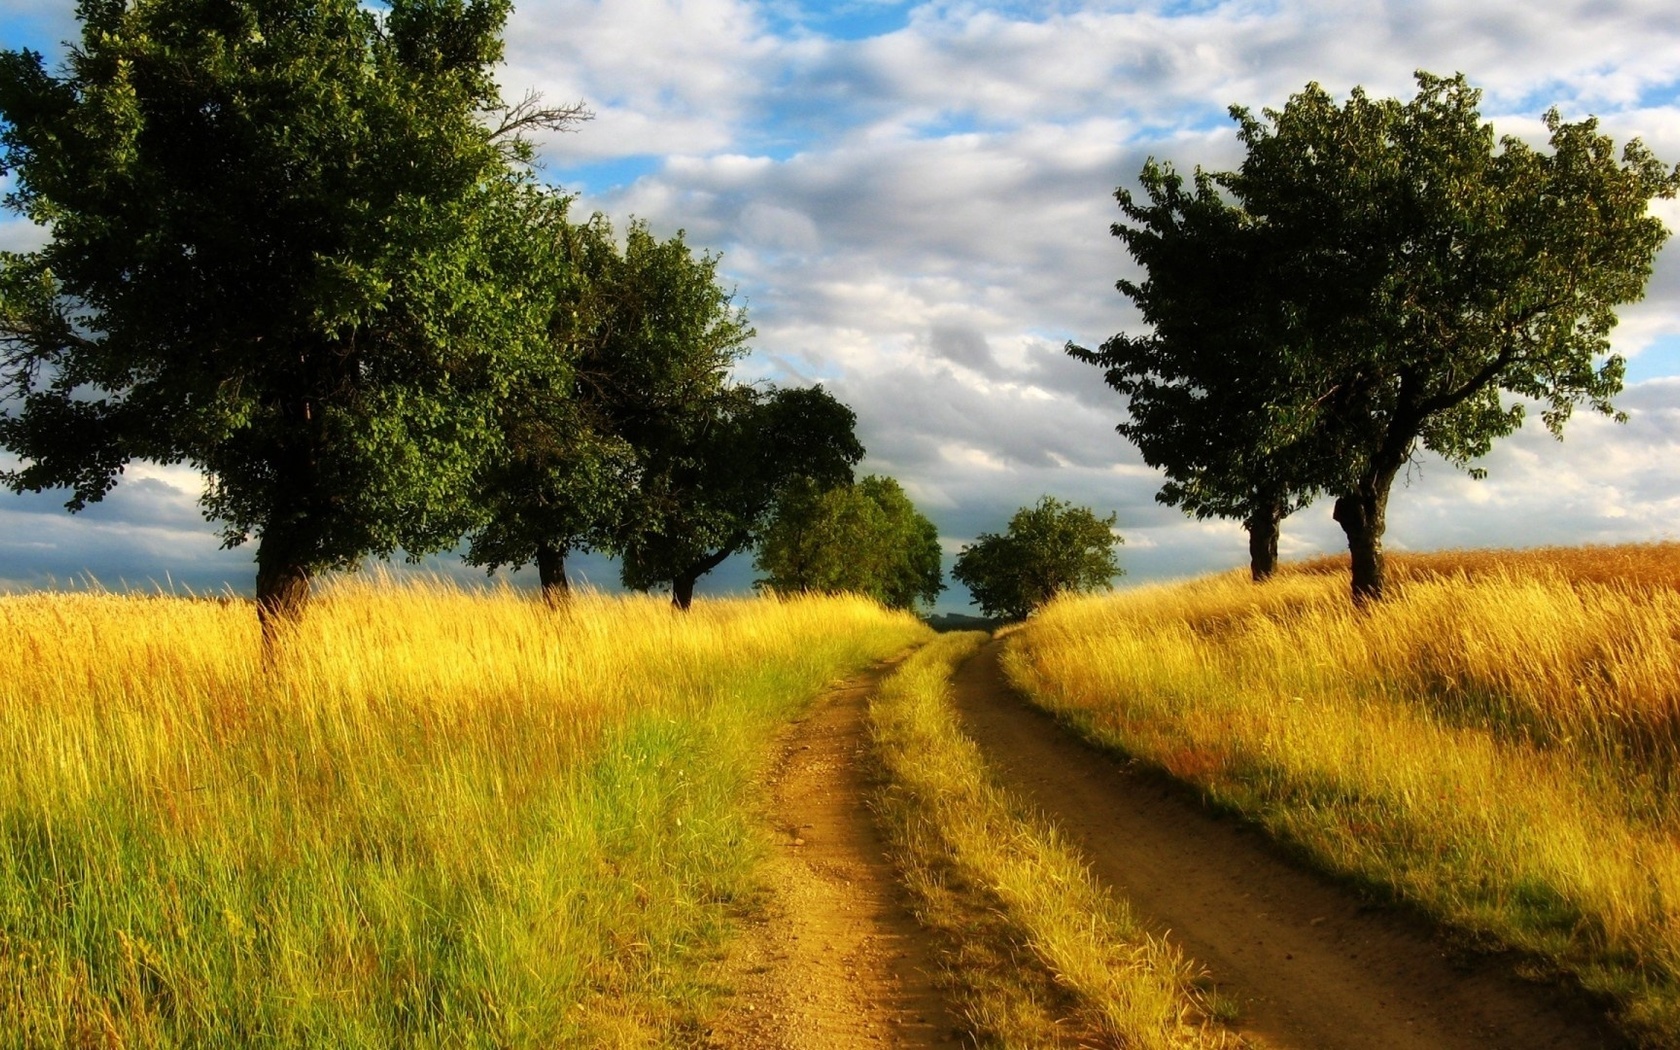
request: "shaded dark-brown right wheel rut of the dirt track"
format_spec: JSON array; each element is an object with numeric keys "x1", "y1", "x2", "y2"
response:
[{"x1": 954, "y1": 642, "x2": 1625, "y2": 1050}]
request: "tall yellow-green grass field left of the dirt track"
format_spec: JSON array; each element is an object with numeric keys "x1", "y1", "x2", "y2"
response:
[{"x1": 0, "y1": 585, "x2": 926, "y2": 1047}]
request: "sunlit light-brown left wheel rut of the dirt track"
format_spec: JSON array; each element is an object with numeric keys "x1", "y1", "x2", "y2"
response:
[{"x1": 707, "y1": 667, "x2": 963, "y2": 1050}]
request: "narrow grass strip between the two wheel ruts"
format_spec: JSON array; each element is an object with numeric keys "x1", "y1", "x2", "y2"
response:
[{"x1": 870, "y1": 633, "x2": 1236, "y2": 1050}]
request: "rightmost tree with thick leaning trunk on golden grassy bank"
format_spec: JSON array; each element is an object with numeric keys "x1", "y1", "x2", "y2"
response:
[{"x1": 1218, "y1": 72, "x2": 1680, "y2": 601}]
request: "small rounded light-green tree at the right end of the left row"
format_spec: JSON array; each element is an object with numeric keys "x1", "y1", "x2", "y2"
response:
[{"x1": 754, "y1": 474, "x2": 944, "y2": 608}]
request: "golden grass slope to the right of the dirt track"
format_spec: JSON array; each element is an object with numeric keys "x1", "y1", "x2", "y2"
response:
[{"x1": 1005, "y1": 544, "x2": 1680, "y2": 1047}]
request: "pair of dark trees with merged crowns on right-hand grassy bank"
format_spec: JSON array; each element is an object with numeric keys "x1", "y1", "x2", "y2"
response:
[{"x1": 1067, "y1": 72, "x2": 1680, "y2": 601}]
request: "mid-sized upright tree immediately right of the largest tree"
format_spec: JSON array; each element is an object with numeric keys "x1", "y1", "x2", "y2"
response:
[{"x1": 467, "y1": 215, "x2": 753, "y2": 600}]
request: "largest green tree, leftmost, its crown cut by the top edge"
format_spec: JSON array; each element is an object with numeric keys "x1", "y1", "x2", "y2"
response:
[{"x1": 0, "y1": 0, "x2": 578, "y2": 627}]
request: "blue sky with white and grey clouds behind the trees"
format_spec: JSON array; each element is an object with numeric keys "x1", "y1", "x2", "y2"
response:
[{"x1": 0, "y1": 0, "x2": 1680, "y2": 612}]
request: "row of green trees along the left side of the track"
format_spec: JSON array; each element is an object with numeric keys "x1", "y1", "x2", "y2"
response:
[{"x1": 0, "y1": 0, "x2": 941, "y2": 632}]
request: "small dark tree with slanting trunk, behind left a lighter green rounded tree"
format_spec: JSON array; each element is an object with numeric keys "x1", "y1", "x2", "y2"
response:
[{"x1": 622, "y1": 386, "x2": 864, "y2": 608}]
